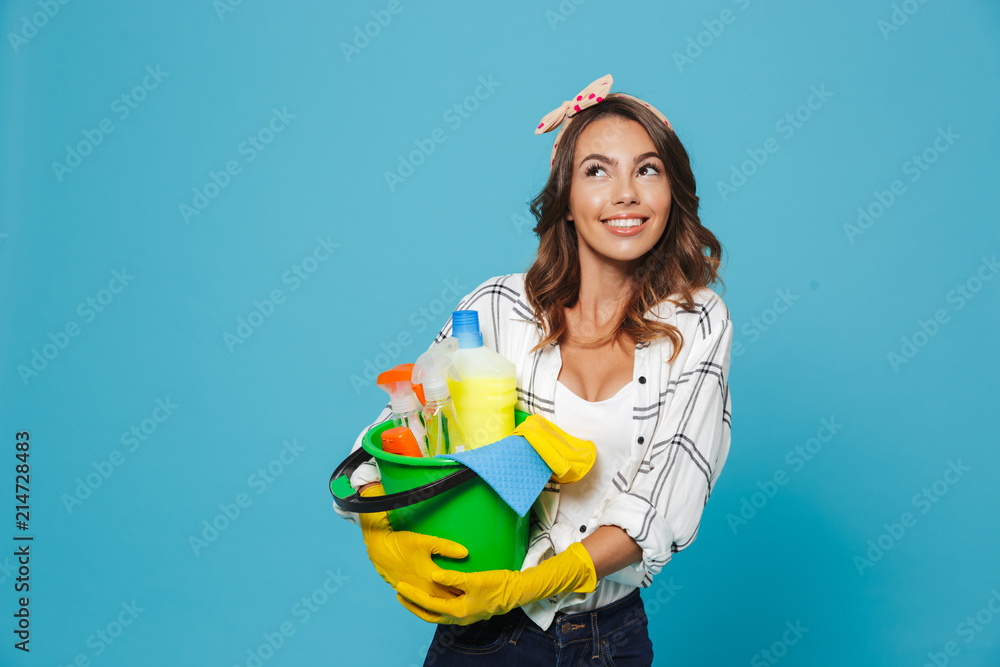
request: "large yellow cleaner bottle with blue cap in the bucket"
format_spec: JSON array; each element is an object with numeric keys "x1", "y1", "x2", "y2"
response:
[{"x1": 452, "y1": 310, "x2": 517, "y2": 449}]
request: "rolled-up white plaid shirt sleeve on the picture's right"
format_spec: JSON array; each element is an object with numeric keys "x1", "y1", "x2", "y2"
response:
[{"x1": 598, "y1": 295, "x2": 733, "y2": 587}]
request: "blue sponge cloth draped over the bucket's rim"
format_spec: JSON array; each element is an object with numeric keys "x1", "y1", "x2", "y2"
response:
[{"x1": 435, "y1": 435, "x2": 552, "y2": 517}]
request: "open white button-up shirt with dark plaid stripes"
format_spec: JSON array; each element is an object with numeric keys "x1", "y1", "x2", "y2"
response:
[{"x1": 334, "y1": 273, "x2": 733, "y2": 629}]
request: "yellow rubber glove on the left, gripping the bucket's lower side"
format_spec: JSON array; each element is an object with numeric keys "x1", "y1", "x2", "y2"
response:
[{"x1": 358, "y1": 484, "x2": 469, "y2": 598}]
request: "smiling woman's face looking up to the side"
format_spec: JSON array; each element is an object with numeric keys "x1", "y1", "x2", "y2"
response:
[{"x1": 567, "y1": 116, "x2": 671, "y2": 262}]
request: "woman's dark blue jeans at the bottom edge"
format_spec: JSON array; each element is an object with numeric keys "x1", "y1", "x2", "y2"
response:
[{"x1": 424, "y1": 589, "x2": 653, "y2": 667}]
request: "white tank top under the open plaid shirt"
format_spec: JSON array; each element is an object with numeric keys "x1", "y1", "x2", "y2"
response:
[{"x1": 553, "y1": 380, "x2": 635, "y2": 613}]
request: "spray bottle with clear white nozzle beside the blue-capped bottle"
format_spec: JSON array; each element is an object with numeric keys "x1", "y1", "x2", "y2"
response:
[{"x1": 413, "y1": 337, "x2": 468, "y2": 456}]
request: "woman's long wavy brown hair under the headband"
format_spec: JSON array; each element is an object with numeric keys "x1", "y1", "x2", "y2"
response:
[{"x1": 524, "y1": 93, "x2": 722, "y2": 363}]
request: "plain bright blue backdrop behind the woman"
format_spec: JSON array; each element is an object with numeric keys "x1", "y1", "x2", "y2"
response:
[{"x1": 0, "y1": 0, "x2": 1000, "y2": 666}]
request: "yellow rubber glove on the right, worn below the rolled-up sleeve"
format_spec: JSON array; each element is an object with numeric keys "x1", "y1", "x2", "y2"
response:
[{"x1": 396, "y1": 542, "x2": 597, "y2": 625}]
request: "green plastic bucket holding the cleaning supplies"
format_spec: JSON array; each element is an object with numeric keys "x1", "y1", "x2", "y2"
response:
[{"x1": 330, "y1": 410, "x2": 529, "y2": 572}]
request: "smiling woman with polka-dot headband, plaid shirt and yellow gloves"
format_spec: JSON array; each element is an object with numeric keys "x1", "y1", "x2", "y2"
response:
[{"x1": 336, "y1": 76, "x2": 732, "y2": 665}]
